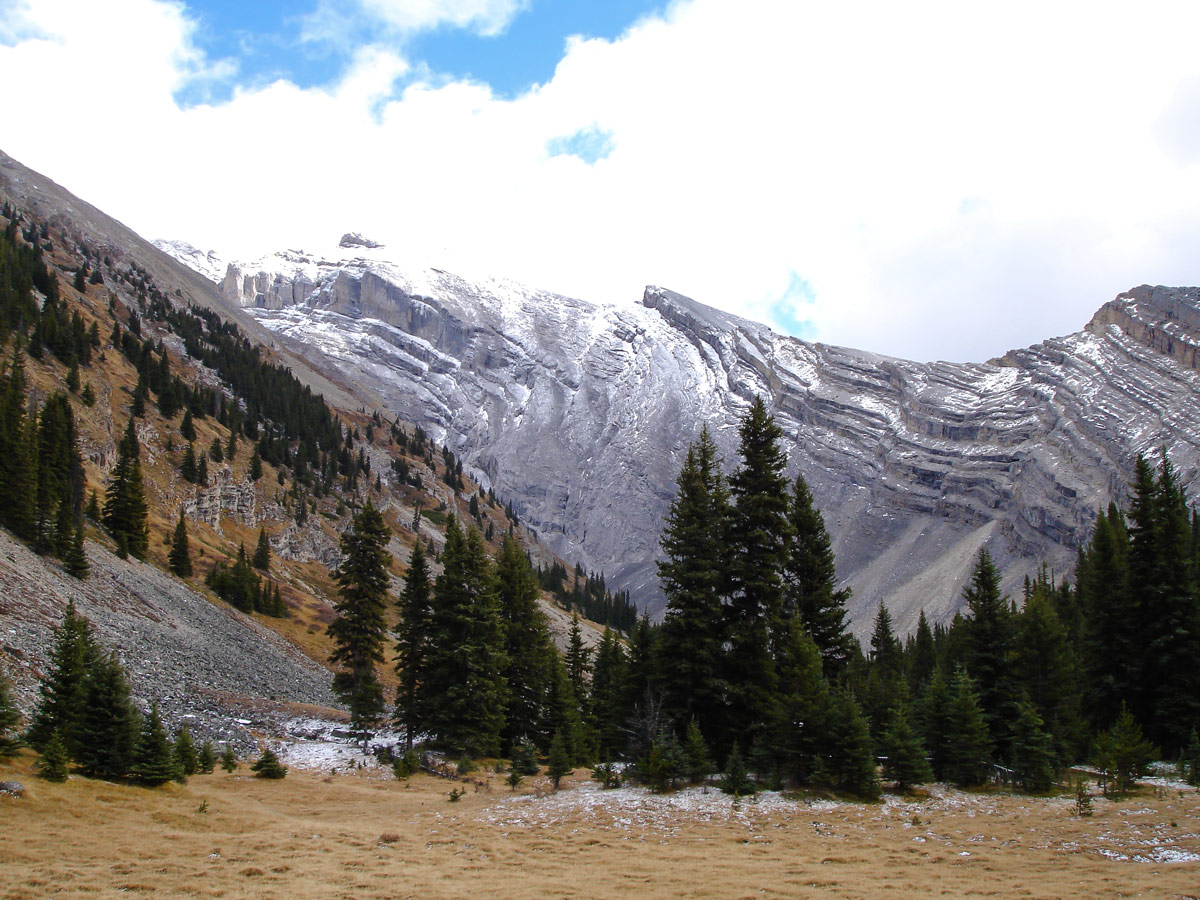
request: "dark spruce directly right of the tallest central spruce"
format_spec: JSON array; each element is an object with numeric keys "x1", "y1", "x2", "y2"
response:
[{"x1": 784, "y1": 475, "x2": 854, "y2": 677}]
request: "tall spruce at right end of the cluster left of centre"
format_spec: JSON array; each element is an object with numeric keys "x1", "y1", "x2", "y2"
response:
[{"x1": 496, "y1": 534, "x2": 554, "y2": 748}]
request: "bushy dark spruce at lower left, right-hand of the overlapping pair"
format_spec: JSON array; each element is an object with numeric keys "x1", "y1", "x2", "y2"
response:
[{"x1": 74, "y1": 653, "x2": 142, "y2": 779}]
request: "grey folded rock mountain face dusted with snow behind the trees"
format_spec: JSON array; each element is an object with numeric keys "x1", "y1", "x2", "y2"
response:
[{"x1": 159, "y1": 241, "x2": 1200, "y2": 631}]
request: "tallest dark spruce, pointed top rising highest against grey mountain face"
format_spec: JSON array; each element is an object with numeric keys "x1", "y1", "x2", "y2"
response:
[{"x1": 725, "y1": 397, "x2": 791, "y2": 738}]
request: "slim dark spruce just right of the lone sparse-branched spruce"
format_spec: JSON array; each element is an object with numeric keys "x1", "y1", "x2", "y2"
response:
[{"x1": 395, "y1": 541, "x2": 433, "y2": 750}]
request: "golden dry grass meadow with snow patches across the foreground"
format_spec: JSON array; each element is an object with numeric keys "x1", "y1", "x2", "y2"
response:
[{"x1": 0, "y1": 755, "x2": 1200, "y2": 900}]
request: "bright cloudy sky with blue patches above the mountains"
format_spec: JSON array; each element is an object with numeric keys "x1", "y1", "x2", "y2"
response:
[{"x1": 0, "y1": 0, "x2": 1200, "y2": 361}]
